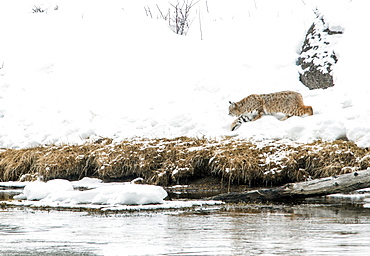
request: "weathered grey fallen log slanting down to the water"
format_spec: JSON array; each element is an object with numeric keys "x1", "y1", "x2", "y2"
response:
[{"x1": 212, "y1": 168, "x2": 370, "y2": 203}]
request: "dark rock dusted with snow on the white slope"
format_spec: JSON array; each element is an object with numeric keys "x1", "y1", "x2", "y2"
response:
[{"x1": 297, "y1": 12, "x2": 343, "y2": 90}]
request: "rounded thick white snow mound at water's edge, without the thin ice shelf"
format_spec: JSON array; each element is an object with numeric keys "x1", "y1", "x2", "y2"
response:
[{"x1": 14, "y1": 179, "x2": 167, "y2": 205}]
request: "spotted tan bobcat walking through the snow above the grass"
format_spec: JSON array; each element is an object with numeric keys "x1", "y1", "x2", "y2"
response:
[{"x1": 229, "y1": 91, "x2": 313, "y2": 131}]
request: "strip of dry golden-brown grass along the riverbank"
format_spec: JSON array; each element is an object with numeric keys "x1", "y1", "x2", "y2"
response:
[{"x1": 0, "y1": 137, "x2": 370, "y2": 187}]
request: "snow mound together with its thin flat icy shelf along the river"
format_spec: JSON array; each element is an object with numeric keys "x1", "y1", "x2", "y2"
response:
[{"x1": 4, "y1": 177, "x2": 223, "y2": 212}]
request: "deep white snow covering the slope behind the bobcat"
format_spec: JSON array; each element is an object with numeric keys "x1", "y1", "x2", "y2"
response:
[{"x1": 0, "y1": 0, "x2": 370, "y2": 148}]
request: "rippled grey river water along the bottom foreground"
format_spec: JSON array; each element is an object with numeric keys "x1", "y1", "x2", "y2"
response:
[{"x1": 0, "y1": 202, "x2": 370, "y2": 256}]
